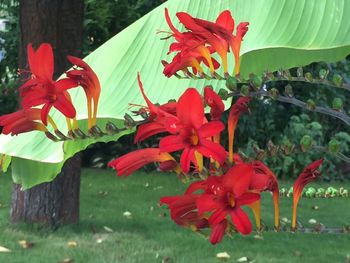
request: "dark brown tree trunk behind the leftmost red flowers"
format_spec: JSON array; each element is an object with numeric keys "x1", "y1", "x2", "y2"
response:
[{"x1": 10, "y1": 0, "x2": 84, "y2": 227}]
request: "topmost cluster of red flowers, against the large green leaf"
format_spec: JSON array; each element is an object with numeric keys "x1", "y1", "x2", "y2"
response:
[{"x1": 163, "y1": 9, "x2": 249, "y2": 77}]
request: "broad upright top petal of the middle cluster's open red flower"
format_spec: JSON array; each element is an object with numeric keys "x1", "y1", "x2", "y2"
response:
[{"x1": 176, "y1": 88, "x2": 204, "y2": 129}]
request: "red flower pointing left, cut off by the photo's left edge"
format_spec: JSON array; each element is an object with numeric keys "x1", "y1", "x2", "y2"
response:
[{"x1": 0, "y1": 109, "x2": 47, "y2": 136}]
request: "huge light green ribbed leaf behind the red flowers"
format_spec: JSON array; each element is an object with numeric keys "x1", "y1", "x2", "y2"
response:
[{"x1": 0, "y1": 0, "x2": 350, "y2": 187}]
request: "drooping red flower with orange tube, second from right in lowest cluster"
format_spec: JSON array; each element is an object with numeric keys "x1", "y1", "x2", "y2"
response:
[{"x1": 249, "y1": 161, "x2": 280, "y2": 229}]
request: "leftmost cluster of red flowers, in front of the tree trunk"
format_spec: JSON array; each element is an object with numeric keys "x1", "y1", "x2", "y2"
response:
[{"x1": 0, "y1": 43, "x2": 100, "y2": 139}]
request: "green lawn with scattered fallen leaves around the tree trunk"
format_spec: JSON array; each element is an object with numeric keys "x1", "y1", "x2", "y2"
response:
[{"x1": 0, "y1": 169, "x2": 350, "y2": 263}]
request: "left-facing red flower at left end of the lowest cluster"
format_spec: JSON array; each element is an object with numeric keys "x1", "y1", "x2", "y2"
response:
[{"x1": 160, "y1": 195, "x2": 209, "y2": 231}]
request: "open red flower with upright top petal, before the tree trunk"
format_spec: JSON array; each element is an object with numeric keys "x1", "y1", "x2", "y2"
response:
[{"x1": 19, "y1": 43, "x2": 77, "y2": 125}]
